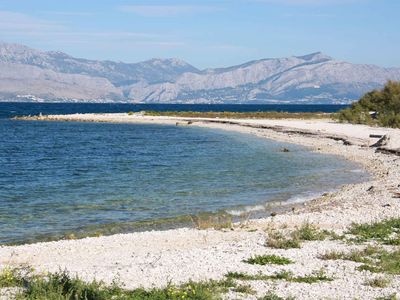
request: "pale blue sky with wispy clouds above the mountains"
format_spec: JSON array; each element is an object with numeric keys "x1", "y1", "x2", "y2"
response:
[{"x1": 0, "y1": 0, "x2": 400, "y2": 69}]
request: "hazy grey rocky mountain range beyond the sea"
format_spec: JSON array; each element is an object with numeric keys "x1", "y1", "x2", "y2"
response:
[{"x1": 0, "y1": 42, "x2": 400, "y2": 104}]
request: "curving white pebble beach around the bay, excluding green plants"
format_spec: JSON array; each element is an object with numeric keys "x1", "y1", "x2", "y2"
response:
[{"x1": 0, "y1": 114, "x2": 400, "y2": 299}]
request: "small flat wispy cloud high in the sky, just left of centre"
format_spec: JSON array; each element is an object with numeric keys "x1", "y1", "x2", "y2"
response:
[{"x1": 117, "y1": 5, "x2": 221, "y2": 17}]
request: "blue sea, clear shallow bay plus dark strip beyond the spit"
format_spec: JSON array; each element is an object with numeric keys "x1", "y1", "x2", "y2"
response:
[{"x1": 0, "y1": 102, "x2": 368, "y2": 244}]
